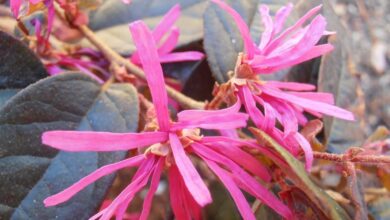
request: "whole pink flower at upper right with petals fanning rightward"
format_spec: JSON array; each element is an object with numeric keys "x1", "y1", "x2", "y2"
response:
[{"x1": 212, "y1": 0, "x2": 354, "y2": 170}]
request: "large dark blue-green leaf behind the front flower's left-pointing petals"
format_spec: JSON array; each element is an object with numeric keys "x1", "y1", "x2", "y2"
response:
[{"x1": 0, "y1": 73, "x2": 139, "y2": 219}]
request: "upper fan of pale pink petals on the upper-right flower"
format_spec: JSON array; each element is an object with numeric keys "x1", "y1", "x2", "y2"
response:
[{"x1": 212, "y1": 0, "x2": 333, "y2": 74}]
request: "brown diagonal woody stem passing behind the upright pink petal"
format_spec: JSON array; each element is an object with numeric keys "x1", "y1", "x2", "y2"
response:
[{"x1": 56, "y1": 7, "x2": 205, "y2": 109}]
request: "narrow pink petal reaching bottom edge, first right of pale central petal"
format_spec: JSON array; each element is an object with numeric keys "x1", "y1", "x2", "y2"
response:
[{"x1": 205, "y1": 159, "x2": 256, "y2": 220}]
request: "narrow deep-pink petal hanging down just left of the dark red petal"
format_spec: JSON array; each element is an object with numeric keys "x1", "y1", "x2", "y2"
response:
[{"x1": 139, "y1": 158, "x2": 165, "y2": 220}]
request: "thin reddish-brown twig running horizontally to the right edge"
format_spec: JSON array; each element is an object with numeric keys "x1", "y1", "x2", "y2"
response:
[{"x1": 314, "y1": 152, "x2": 390, "y2": 164}]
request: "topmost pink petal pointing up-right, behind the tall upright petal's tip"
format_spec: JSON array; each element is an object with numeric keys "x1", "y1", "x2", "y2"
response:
[{"x1": 153, "y1": 4, "x2": 180, "y2": 42}]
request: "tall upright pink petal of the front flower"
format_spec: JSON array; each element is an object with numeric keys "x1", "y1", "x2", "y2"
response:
[{"x1": 130, "y1": 21, "x2": 170, "y2": 131}]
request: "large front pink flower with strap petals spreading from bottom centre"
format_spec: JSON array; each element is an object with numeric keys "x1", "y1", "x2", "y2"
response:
[{"x1": 42, "y1": 21, "x2": 292, "y2": 219}]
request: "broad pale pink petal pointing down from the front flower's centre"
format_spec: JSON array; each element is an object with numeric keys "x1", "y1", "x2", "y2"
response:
[{"x1": 169, "y1": 133, "x2": 212, "y2": 207}]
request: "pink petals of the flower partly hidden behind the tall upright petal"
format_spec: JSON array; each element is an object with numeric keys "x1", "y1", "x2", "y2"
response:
[{"x1": 130, "y1": 4, "x2": 204, "y2": 65}]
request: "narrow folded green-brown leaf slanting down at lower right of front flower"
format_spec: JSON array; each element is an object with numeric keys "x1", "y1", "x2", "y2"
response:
[{"x1": 250, "y1": 128, "x2": 350, "y2": 220}]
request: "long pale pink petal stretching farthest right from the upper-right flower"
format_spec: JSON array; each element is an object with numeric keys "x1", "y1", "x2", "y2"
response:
[{"x1": 260, "y1": 86, "x2": 354, "y2": 121}]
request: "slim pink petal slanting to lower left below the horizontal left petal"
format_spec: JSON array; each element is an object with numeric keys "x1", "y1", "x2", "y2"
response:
[{"x1": 43, "y1": 155, "x2": 145, "y2": 207}]
